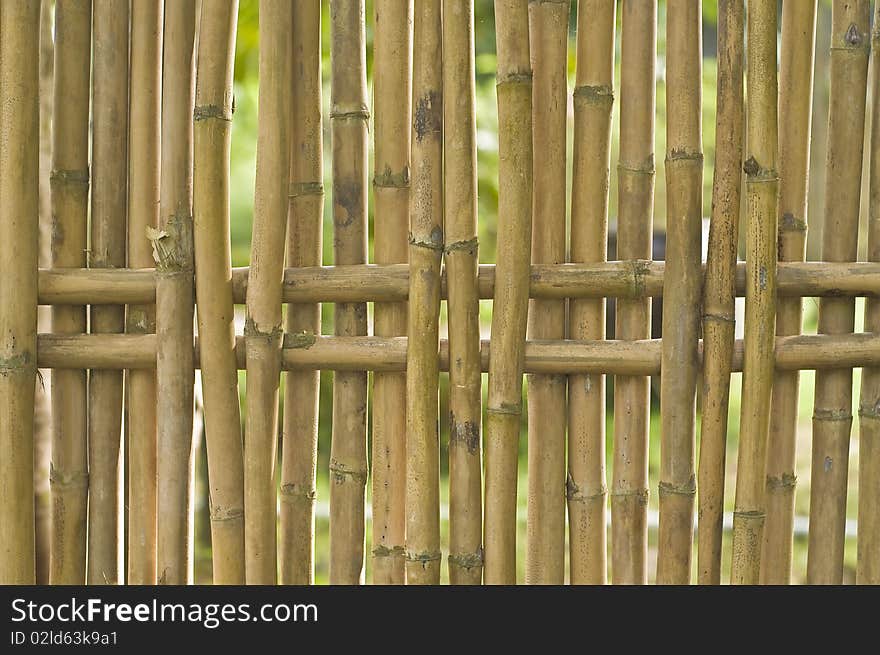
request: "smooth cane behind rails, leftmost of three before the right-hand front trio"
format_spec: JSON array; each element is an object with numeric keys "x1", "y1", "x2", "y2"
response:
[{"x1": 526, "y1": 0, "x2": 568, "y2": 584}]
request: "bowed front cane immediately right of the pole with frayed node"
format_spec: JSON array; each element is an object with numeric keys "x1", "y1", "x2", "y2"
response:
[{"x1": 193, "y1": 0, "x2": 245, "y2": 584}]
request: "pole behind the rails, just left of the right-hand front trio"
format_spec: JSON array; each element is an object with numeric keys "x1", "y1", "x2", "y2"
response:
[{"x1": 612, "y1": 0, "x2": 657, "y2": 584}]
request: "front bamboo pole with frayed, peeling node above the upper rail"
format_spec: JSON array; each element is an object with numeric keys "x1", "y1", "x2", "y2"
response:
[{"x1": 151, "y1": 0, "x2": 196, "y2": 584}]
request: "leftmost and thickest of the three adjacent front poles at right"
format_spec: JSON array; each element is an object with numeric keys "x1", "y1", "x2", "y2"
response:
[{"x1": 657, "y1": 0, "x2": 703, "y2": 584}]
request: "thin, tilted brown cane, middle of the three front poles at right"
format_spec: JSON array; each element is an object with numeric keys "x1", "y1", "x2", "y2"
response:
[{"x1": 697, "y1": 0, "x2": 744, "y2": 585}]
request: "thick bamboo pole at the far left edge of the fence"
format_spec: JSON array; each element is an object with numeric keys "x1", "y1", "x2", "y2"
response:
[{"x1": 0, "y1": 0, "x2": 40, "y2": 584}]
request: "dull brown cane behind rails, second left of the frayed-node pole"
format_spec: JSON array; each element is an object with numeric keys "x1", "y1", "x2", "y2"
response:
[{"x1": 88, "y1": 0, "x2": 129, "y2": 584}]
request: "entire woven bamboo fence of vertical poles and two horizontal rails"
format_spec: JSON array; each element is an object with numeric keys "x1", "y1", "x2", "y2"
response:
[{"x1": 0, "y1": 0, "x2": 880, "y2": 584}]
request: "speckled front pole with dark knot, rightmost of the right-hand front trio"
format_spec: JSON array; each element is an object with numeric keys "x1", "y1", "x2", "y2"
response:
[{"x1": 730, "y1": 0, "x2": 779, "y2": 584}]
